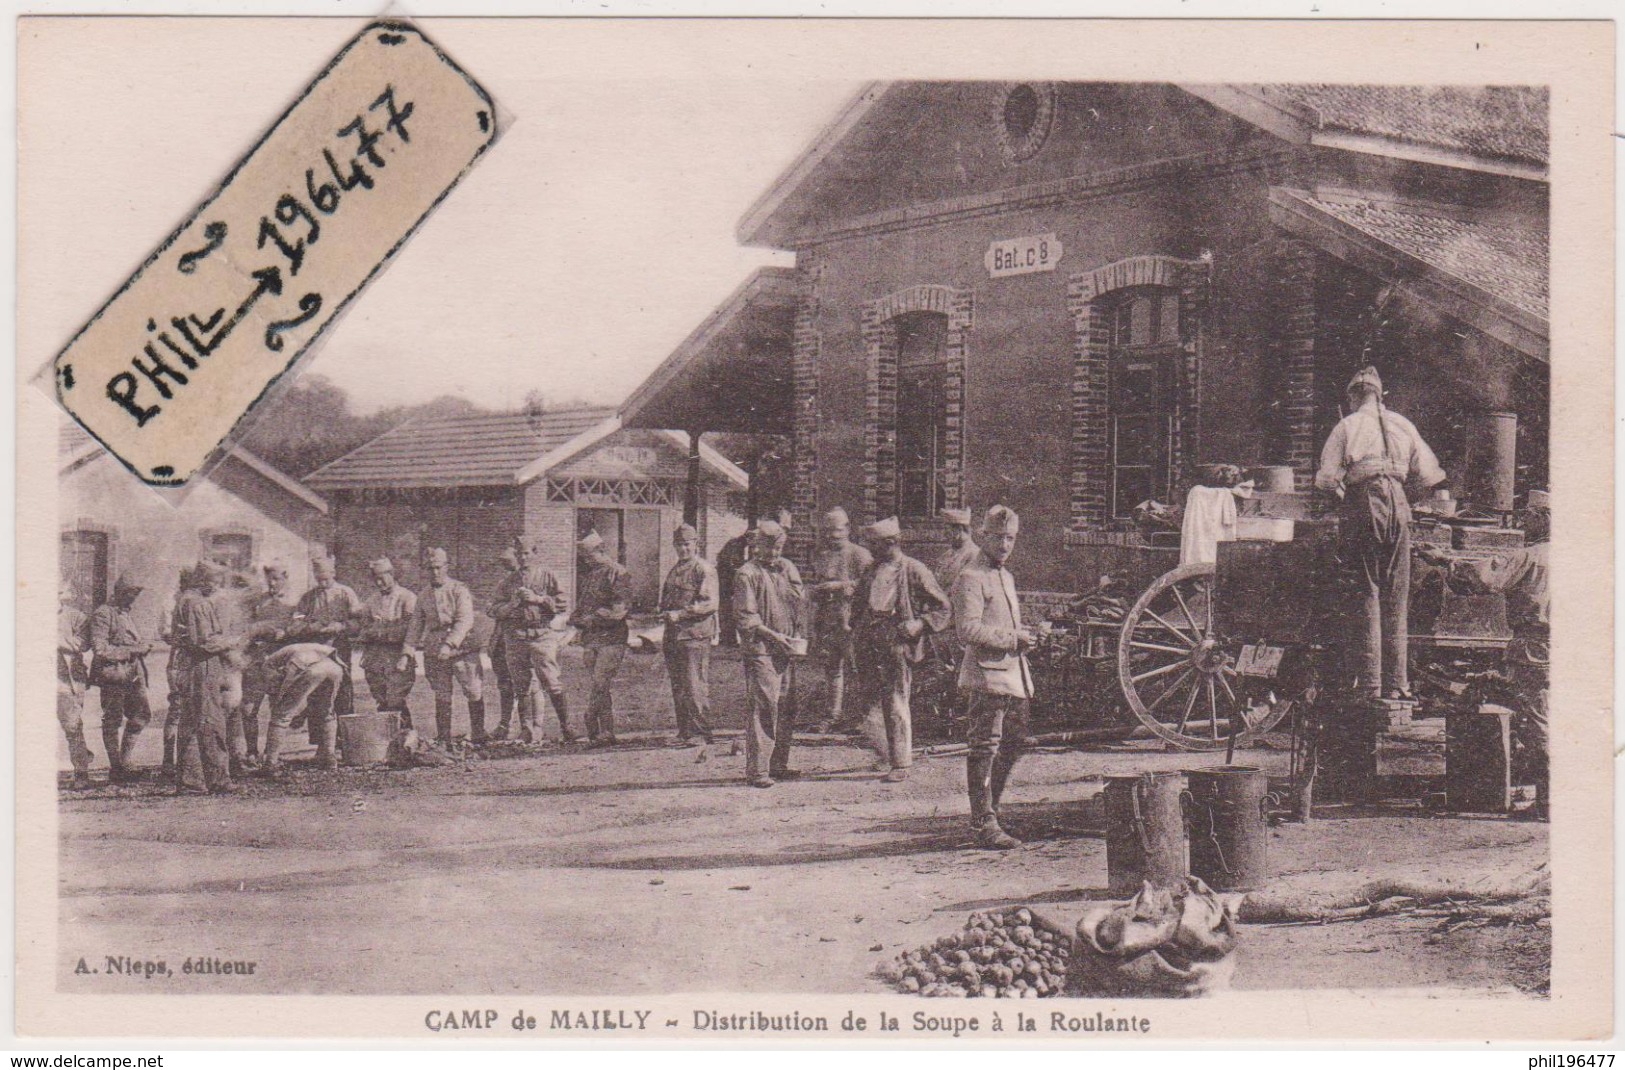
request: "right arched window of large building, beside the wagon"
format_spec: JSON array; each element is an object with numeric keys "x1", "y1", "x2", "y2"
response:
[{"x1": 1107, "y1": 286, "x2": 1180, "y2": 519}]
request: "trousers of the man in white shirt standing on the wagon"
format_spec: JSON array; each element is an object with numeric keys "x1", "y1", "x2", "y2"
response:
[{"x1": 1337, "y1": 476, "x2": 1411, "y2": 694}]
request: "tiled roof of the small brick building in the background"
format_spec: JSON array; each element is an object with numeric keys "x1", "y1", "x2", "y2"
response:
[{"x1": 304, "y1": 408, "x2": 614, "y2": 489}]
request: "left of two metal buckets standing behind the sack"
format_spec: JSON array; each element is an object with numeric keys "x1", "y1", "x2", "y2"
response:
[{"x1": 1105, "y1": 772, "x2": 1186, "y2": 896}]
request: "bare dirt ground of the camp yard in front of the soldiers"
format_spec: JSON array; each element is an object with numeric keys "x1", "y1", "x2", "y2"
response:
[{"x1": 59, "y1": 657, "x2": 1550, "y2": 997}]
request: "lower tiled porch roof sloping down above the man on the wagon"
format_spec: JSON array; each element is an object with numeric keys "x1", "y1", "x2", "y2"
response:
[{"x1": 1294, "y1": 194, "x2": 1549, "y2": 320}]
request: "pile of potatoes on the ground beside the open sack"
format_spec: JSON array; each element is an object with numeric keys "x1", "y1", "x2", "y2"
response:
[{"x1": 876, "y1": 907, "x2": 1069, "y2": 1000}]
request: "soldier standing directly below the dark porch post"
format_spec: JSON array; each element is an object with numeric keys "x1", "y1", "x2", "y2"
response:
[{"x1": 660, "y1": 524, "x2": 717, "y2": 746}]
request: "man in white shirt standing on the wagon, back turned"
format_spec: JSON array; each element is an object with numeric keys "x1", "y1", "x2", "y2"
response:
[{"x1": 1315, "y1": 368, "x2": 1445, "y2": 699}]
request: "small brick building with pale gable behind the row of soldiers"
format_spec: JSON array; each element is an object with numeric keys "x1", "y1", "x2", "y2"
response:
[{"x1": 306, "y1": 408, "x2": 746, "y2": 608}]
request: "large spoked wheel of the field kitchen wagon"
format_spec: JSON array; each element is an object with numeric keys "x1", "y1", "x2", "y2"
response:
[{"x1": 1118, "y1": 564, "x2": 1292, "y2": 750}]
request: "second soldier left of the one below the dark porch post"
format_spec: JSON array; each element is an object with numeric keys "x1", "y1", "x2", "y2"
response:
[{"x1": 496, "y1": 545, "x2": 575, "y2": 743}]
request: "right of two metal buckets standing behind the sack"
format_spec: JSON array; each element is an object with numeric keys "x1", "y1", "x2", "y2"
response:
[{"x1": 1185, "y1": 766, "x2": 1269, "y2": 891}]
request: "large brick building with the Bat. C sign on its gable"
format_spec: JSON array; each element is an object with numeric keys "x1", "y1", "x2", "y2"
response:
[{"x1": 621, "y1": 83, "x2": 1549, "y2": 590}]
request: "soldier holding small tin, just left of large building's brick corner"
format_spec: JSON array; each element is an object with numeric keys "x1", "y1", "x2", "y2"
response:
[{"x1": 733, "y1": 520, "x2": 803, "y2": 787}]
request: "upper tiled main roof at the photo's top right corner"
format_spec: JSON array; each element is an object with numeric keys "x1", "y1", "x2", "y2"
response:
[{"x1": 1253, "y1": 85, "x2": 1549, "y2": 167}]
